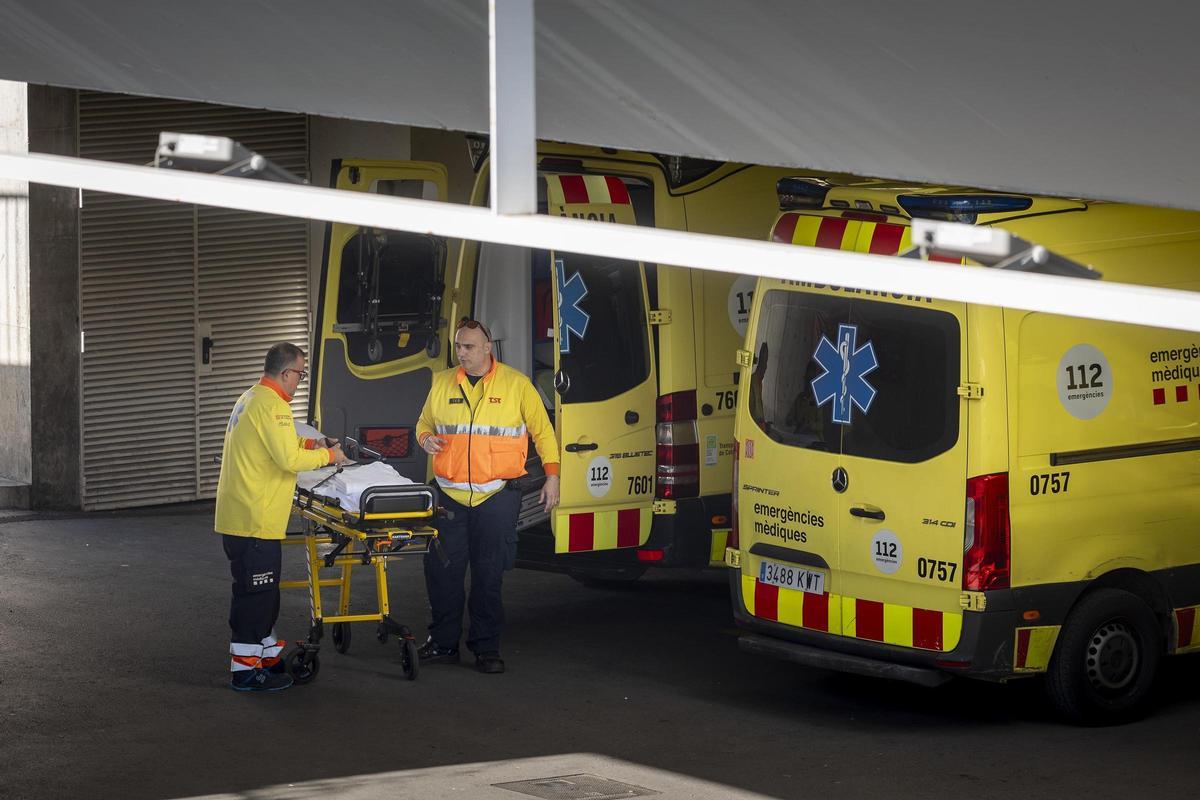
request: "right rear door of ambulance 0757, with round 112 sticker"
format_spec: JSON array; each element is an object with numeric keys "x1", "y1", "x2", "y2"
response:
[{"x1": 835, "y1": 296, "x2": 967, "y2": 652}]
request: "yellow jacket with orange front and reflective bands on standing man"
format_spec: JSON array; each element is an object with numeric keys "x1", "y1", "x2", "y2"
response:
[{"x1": 416, "y1": 357, "x2": 559, "y2": 506}]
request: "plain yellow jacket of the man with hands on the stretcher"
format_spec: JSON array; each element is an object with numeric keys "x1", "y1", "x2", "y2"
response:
[{"x1": 215, "y1": 378, "x2": 332, "y2": 539}]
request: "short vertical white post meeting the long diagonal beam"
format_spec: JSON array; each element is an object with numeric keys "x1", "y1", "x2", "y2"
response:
[{"x1": 487, "y1": 0, "x2": 538, "y2": 213}]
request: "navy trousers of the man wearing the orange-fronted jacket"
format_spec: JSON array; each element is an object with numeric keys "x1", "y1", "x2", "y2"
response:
[{"x1": 425, "y1": 488, "x2": 521, "y2": 652}]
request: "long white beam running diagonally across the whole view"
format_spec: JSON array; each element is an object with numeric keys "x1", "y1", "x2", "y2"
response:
[{"x1": 0, "y1": 154, "x2": 1200, "y2": 332}]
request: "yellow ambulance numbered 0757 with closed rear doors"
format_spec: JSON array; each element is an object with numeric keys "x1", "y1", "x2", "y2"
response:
[{"x1": 726, "y1": 180, "x2": 1200, "y2": 721}]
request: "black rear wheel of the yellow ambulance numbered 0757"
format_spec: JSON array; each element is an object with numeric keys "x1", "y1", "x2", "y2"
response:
[{"x1": 1045, "y1": 589, "x2": 1163, "y2": 724}]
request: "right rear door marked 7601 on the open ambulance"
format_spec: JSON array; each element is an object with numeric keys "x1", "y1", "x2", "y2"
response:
[{"x1": 546, "y1": 174, "x2": 658, "y2": 553}]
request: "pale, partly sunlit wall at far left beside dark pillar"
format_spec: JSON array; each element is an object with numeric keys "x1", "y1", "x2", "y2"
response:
[{"x1": 0, "y1": 80, "x2": 31, "y2": 483}]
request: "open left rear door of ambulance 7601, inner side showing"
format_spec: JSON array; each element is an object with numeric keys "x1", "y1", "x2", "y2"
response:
[{"x1": 308, "y1": 161, "x2": 457, "y2": 481}]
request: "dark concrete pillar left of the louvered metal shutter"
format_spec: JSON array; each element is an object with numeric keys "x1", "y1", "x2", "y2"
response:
[{"x1": 28, "y1": 85, "x2": 83, "y2": 509}]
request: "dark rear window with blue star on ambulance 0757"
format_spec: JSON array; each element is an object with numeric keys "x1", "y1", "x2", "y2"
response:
[{"x1": 749, "y1": 290, "x2": 960, "y2": 463}]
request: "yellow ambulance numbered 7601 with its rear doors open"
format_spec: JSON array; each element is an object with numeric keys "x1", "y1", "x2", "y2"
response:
[{"x1": 310, "y1": 139, "x2": 806, "y2": 582}]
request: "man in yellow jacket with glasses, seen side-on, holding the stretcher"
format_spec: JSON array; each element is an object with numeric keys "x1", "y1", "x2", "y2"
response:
[{"x1": 215, "y1": 342, "x2": 346, "y2": 692}]
